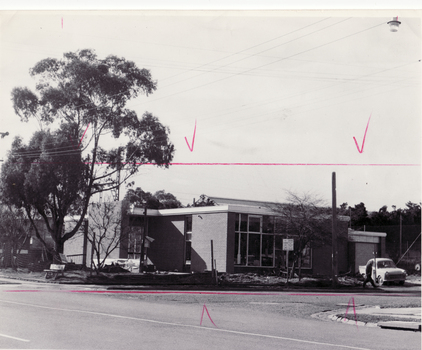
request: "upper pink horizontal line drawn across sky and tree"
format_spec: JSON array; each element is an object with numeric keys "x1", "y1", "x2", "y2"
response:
[{"x1": 11, "y1": 162, "x2": 421, "y2": 167}]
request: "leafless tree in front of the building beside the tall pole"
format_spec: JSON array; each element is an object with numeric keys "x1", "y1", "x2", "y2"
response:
[{"x1": 273, "y1": 191, "x2": 331, "y2": 279}]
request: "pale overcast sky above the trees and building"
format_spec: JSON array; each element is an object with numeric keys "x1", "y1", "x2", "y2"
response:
[{"x1": 0, "y1": 10, "x2": 422, "y2": 211}]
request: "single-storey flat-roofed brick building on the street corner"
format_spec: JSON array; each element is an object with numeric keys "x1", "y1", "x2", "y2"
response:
[{"x1": 65, "y1": 198, "x2": 385, "y2": 275}]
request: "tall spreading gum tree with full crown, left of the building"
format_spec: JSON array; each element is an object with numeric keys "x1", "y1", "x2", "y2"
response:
[{"x1": 2, "y1": 50, "x2": 174, "y2": 253}]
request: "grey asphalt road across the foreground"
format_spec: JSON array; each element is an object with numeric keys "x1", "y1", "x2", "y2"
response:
[{"x1": 0, "y1": 283, "x2": 421, "y2": 350}]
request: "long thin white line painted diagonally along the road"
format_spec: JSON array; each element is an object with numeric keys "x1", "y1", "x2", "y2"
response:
[{"x1": 0, "y1": 300, "x2": 371, "y2": 350}]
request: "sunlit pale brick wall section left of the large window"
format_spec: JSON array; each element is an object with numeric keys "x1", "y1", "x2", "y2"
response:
[{"x1": 191, "y1": 213, "x2": 228, "y2": 272}]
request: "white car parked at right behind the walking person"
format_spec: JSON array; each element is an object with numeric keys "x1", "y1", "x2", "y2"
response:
[{"x1": 359, "y1": 258, "x2": 407, "y2": 286}]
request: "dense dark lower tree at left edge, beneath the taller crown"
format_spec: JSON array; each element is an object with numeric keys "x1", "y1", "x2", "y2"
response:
[{"x1": 1, "y1": 126, "x2": 87, "y2": 252}]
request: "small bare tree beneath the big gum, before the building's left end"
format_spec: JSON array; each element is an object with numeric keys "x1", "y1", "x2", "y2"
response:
[{"x1": 87, "y1": 202, "x2": 129, "y2": 273}]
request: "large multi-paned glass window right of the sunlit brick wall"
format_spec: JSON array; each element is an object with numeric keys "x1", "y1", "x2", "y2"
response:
[{"x1": 234, "y1": 214, "x2": 275, "y2": 267}]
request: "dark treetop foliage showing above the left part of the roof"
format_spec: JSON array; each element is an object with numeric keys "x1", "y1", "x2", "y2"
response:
[{"x1": 124, "y1": 187, "x2": 182, "y2": 209}]
